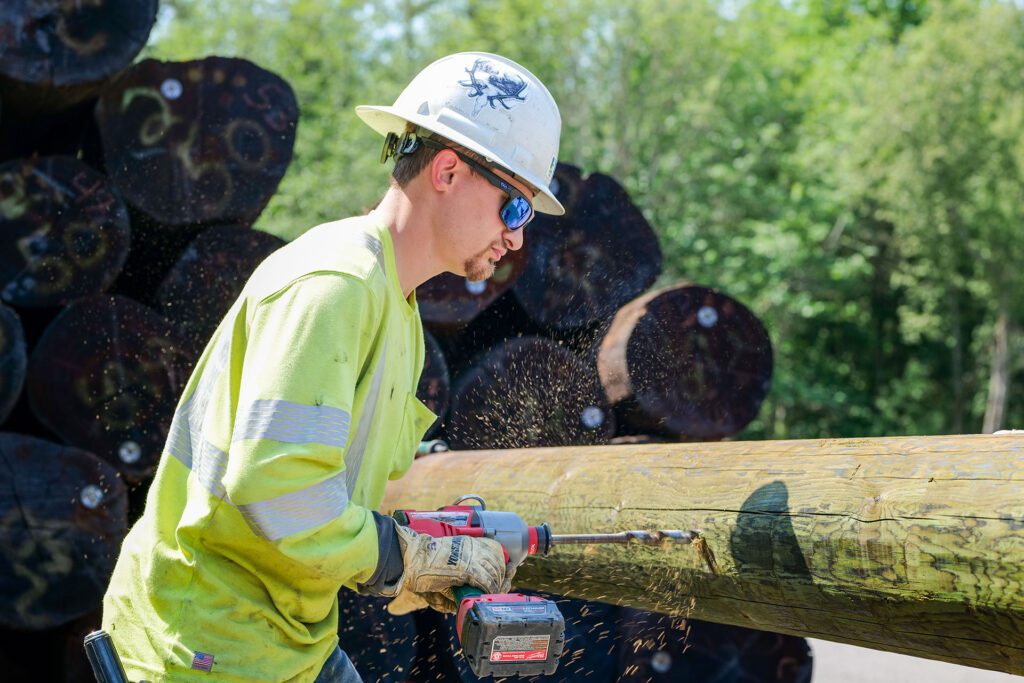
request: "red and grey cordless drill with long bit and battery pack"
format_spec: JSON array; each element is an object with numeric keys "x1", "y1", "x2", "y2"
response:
[{"x1": 393, "y1": 494, "x2": 698, "y2": 677}]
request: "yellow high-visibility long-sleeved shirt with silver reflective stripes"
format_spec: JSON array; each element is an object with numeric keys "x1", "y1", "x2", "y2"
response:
[{"x1": 103, "y1": 214, "x2": 436, "y2": 683}]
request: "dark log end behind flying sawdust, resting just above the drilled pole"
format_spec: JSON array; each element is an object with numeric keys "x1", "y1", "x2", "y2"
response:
[{"x1": 445, "y1": 337, "x2": 614, "y2": 449}]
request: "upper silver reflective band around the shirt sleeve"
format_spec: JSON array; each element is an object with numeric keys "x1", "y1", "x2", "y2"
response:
[{"x1": 231, "y1": 399, "x2": 351, "y2": 449}]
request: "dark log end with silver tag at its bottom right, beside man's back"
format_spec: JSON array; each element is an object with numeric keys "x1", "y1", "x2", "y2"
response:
[{"x1": 27, "y1": 296, "x2": 188, "y2": 483}]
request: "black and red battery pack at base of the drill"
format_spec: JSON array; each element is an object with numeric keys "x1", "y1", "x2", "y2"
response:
[{"x1": 456, "y1": 593, "x2": 565, "y2": 677}]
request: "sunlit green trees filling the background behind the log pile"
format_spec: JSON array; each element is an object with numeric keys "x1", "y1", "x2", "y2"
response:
[{"x1": 148, "y1": 0, "x2": 1024, "y2": 438}]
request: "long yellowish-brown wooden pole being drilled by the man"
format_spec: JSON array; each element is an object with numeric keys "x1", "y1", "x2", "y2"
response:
[{"x1": 384, "y1": 434, "x2": 1024, "y2": 674}]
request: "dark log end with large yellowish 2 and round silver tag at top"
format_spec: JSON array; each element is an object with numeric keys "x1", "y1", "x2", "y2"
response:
[{"x1": 96, "y1": 57, "x2": 299, "y2": 226}]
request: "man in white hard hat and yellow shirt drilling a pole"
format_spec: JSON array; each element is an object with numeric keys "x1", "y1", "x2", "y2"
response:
[{"x1": 103, "y1": 53, "x2": 563, "y2": 682}]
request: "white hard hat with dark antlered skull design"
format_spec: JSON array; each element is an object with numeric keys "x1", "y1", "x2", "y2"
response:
[{"x1": 355, "y1": 52, "x2": 565, "y2": 216}]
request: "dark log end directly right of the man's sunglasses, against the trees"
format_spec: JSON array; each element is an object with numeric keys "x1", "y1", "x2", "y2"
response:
[{"x1": 512, "y1": 170, "x2": 662, "y2": 331}]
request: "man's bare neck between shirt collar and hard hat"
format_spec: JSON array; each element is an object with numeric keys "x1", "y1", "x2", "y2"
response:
[{"x1": 374, "y1": 185, "x2": 443, "y2": 299}]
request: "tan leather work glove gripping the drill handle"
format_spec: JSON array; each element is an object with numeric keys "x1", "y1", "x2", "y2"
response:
[{"x1": 387, "y1": 525, "x2": 515, "y2": 614}]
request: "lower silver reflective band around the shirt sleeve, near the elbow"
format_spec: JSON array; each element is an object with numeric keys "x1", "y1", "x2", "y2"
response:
[{"x1": 238, "y1": 472, "x2": 348, "y2": 541}]
